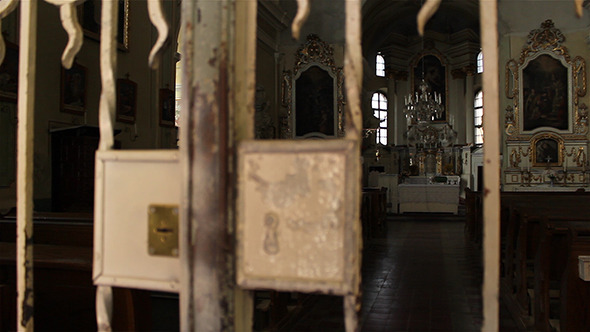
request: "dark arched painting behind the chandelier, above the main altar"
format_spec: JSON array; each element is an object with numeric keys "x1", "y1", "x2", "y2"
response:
[{"x1": 413, "y1": 54, "x2": 447, "y2": 121}]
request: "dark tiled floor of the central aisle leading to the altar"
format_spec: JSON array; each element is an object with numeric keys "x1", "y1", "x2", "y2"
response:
[{"x1": 285, "y1": 214, "x2": 516, "y2": 332}]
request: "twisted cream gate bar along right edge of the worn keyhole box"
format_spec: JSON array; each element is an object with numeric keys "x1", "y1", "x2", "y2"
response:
[{"x1": 344, "y1": 0, "x2": 363, "y2": 332}]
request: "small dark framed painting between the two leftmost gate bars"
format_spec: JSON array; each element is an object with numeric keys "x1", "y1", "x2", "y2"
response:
[{"x1": 60, "y1": 63, "x2": 88, "y2": 115}]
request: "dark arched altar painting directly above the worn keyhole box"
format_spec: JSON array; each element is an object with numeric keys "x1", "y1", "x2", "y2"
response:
[{"x1": 295, "y1": 66, "x2": 336, "y2": 136}]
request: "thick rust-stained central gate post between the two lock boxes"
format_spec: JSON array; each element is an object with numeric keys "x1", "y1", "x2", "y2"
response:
[{"x1": 181, "y1": 0, "x2": 234, "y2": 331}]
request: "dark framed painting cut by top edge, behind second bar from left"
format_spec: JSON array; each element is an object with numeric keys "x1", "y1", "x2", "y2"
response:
[{"x1": 78, "y1": 0, "x2": 129, "y2": 51}]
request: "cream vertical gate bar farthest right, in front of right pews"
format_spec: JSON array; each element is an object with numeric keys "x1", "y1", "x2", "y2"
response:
[{"x1": 479, "y1": 0, "x2": 502, "y2": 332}]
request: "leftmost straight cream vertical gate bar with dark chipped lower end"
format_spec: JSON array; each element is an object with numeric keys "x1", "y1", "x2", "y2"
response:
[{"x1": 16, "y1": 0, "x2": 37, "y2": 331}]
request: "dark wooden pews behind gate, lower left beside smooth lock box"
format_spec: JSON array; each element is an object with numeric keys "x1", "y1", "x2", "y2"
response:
[{"x1": 0, "y1": 213, "x2": 151, "y2": 331}]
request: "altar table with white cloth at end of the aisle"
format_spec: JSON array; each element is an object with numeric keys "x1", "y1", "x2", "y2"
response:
[{"x1": 398, "y1": 176, "x2": 460, "y2": 214}]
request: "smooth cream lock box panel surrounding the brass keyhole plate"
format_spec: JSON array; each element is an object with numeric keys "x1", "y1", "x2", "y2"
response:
[{"x1": 94, "y1": 150, "x2": 180, "y2": 292}]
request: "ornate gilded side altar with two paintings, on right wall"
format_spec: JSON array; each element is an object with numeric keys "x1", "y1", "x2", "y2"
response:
[{"x1": 504, "y1": 20, "x2": 588, "y2": 190}]
